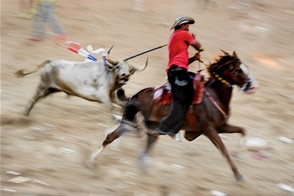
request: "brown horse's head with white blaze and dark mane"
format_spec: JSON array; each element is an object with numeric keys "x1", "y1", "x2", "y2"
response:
[{"x1": 208, "y1": 51, "x2": 258, "y2": 94}]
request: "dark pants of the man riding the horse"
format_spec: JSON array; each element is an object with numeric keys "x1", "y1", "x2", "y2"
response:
[{"x1": 158, "y1": 65, "x2": 194, "y2": 134}]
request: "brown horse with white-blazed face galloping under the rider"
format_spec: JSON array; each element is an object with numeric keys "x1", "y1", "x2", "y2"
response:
[{"x1": 88, "y1": 51, "x2": 257, "y2": 181}]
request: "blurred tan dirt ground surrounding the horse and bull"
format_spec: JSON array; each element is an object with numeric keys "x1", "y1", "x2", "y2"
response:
[{"x1": 0, "y1": 0, "x2": 294, "y2": 196}]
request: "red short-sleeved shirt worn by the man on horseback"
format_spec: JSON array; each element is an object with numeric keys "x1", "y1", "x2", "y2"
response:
[{"x1": 166, "y1": 29, "x2": 195, "y2": 71}]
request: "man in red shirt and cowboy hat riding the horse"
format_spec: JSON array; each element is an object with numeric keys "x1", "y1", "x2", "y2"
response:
[{"x1": 156, "y1": 16, "x2": 203, "y2": 136}]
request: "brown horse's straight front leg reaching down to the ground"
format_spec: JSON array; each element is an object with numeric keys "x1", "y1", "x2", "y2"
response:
[{"x1": 204, "y1": 129, "x2": 243, "y2": 181}]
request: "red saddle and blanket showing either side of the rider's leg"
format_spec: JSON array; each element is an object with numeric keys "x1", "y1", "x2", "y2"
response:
[{"x1": 153, "y1": 72, "x2": 205, "y2": 105}]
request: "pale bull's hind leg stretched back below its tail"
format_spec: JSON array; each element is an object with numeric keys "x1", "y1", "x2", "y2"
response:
[{"x1": 22, "y1": 84, "x2": 59, "y2": 116}]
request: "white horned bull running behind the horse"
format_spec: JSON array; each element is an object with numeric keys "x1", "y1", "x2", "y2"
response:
[{"x1": 16, "y1": 49, "x2": 148, "y2": 118}]
